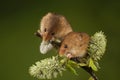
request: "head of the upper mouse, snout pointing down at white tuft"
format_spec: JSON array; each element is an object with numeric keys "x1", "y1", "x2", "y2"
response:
[{"x1": 40, "y1": 13, "x2": 59, "y2": 42}]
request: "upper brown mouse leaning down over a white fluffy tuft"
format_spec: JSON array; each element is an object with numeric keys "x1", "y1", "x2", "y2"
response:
[{"x1": 40, "y1": 13, "x2": 72, "y2": 42}]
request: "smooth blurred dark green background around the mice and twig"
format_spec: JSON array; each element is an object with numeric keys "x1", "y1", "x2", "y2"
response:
[{"x1": 0, "y1": 0, "x2": 120, "y2": 80}]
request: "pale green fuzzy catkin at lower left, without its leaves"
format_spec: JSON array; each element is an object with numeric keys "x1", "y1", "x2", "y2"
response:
[{"x1": 29, "y1": 56, "x2": 65, "y2": 79}]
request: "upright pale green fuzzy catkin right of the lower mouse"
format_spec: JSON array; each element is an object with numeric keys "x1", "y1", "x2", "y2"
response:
[{"x1": 88, "y1": 31, "x2": 107, "y2": 68}]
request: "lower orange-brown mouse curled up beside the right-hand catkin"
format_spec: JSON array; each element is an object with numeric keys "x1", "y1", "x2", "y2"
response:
[{"x1": 59, "y1": 32, "x2": 89, "y2": 58}]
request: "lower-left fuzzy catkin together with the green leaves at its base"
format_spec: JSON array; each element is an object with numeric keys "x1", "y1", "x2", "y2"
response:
[{"x1": 29, "y1": 55, "x2": 79, "y2": 79}]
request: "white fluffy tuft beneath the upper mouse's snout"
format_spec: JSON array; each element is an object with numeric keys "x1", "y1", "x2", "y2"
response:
[{"x1": 40, "y1": 41, "x2": 53, "y2": 54}]
